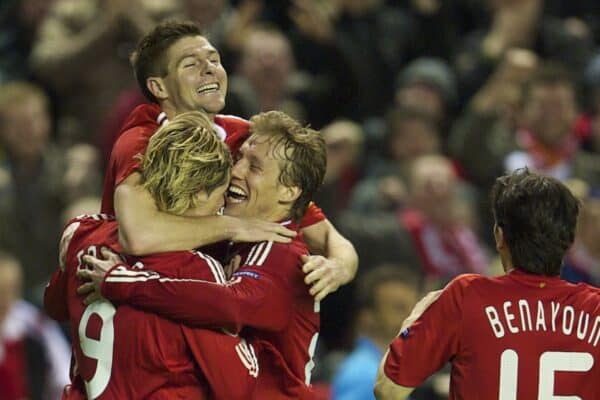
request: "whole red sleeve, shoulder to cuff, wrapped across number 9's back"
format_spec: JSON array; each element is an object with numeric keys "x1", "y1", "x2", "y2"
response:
[{"x1": 102, "y1": 242, "x2": 301, "y2": 331}]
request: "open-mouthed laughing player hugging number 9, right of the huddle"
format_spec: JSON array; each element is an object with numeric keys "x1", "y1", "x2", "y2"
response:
[{"x1": 82, "y1": 111, "x2": 327, "y2": 399}]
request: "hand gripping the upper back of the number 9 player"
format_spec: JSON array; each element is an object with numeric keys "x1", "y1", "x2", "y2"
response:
[{"x1": 77, "y1": 247, "x2": 123, "y2": 305}]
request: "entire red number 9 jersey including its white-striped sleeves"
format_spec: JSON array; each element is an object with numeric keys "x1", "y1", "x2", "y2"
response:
[{"x1": 44, "y1": 214, "x2": 258, "y2": 400}]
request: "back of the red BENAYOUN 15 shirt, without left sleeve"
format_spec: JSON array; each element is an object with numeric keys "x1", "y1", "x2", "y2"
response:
[{"x1": 451, "y1": 271, "x2": 600, "y2": 400}]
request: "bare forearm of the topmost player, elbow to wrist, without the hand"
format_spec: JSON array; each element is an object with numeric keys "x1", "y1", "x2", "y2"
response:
[{"x1": 115, "y1": 180, "x2": 234, "y2": 256}]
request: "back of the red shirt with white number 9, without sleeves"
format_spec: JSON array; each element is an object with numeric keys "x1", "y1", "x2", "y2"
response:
[{"x1": 63, "y1": 215, "x2": 205, "y2": 399}]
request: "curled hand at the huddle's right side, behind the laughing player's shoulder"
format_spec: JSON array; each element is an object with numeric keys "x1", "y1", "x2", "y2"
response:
[{"x1": 301, "y1": 255, "x2": 349, "y2": 301}]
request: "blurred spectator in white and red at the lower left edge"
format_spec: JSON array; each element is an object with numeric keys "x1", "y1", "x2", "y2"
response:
[{"x1": 0, "y1": 250, "x2": 70, "y2": 400}]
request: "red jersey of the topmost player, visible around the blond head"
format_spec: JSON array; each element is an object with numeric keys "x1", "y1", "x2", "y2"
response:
[{"x1": 101, "y1": 104, "x2": 326, "y2": 227}]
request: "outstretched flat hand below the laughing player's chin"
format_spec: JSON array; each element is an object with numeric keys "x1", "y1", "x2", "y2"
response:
[{"x1": 231, "y1": 218, "x2": 296, "y2": 243}]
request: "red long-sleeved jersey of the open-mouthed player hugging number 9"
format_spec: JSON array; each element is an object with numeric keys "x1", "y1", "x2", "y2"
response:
[{"x1": 102, "y1": 220, "x2": 320, "y2": 400}]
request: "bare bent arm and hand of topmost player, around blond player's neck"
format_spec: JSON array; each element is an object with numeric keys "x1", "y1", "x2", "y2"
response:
[{"x1": 114, "y1": 172, "x2": 295, "y2": 255}]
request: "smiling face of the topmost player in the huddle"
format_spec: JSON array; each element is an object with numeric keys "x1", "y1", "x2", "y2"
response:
[{"x1": 155, "y1": 36, "x2": 227, "y2": 116}]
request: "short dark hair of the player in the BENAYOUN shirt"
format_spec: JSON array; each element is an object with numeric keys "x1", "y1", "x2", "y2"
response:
[{"x1": 491, "y1": 168, "x2": 580, "y2": 275}]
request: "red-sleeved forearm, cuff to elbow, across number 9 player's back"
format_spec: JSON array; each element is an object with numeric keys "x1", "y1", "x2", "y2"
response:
[{"x1": 102, "y1": 268, "x2": 289, "y2": 331}]
